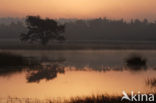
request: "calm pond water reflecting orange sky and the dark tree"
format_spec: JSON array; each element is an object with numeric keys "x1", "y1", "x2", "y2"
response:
[{"x1": 0, "y1": 50, "x2": 156, "y2": 99}]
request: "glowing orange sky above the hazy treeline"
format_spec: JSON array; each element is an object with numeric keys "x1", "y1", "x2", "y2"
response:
[{"x1": 0, "y1": 0, "x2": 156, "y2": 20}]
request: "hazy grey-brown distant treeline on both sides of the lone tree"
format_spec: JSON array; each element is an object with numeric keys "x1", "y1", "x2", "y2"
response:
[{"x1": 0, "y1": 18, "x2": 156, "y2": 41}]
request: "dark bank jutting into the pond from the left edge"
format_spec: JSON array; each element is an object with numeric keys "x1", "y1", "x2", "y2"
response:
[{"x1": 0, "y1": 52, "x2": 40, "y2": 76}]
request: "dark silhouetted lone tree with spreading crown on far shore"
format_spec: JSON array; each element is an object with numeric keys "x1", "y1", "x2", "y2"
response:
[{"x1": 20, "y1": 16, "x2": 65, "y2": 45}]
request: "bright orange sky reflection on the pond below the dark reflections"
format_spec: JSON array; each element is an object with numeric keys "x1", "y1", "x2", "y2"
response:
[{"x1": 0, "y1": 67, "x2": 156, "y2": 98}]
